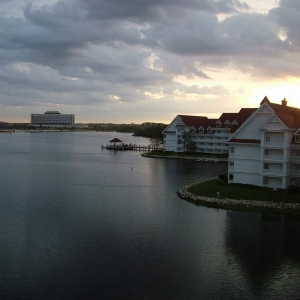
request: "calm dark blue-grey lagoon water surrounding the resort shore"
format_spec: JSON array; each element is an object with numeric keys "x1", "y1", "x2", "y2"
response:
[{"x1": 0, "y1": 132, "x2": 300, "y2": 300}]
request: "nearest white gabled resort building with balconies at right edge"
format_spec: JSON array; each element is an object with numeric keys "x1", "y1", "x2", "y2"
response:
[{"x1": 227, "y1": 97, "x2": 300, "y2": 189}]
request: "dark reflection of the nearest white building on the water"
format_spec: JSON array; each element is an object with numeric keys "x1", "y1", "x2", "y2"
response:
[{"x1": 226, "y1": 211, "x2": 300, "y2": 299}]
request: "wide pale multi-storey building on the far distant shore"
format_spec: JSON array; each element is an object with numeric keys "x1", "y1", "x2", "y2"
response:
[{"x1": 30, "y1": 111, "x2": 75, "y2": 127}]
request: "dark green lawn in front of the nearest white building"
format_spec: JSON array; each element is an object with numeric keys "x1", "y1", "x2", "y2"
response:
[{"x1": 188, "y1": 179, "x2": 300, "y2": 203}]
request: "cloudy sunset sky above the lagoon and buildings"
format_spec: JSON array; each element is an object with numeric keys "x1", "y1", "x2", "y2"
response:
[{"x1": 0, "y1": 0, "x2": 300, "y2": 123}]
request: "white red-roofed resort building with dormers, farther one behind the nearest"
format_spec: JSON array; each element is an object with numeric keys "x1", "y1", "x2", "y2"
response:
[{"x1": 163, "y1": 108, "x2": 256, "y2": 154}]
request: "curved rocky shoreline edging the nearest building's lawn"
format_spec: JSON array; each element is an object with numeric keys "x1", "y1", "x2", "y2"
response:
[{"x1": 176, "y1": 177, "x2": 300, "y2": 216}]
